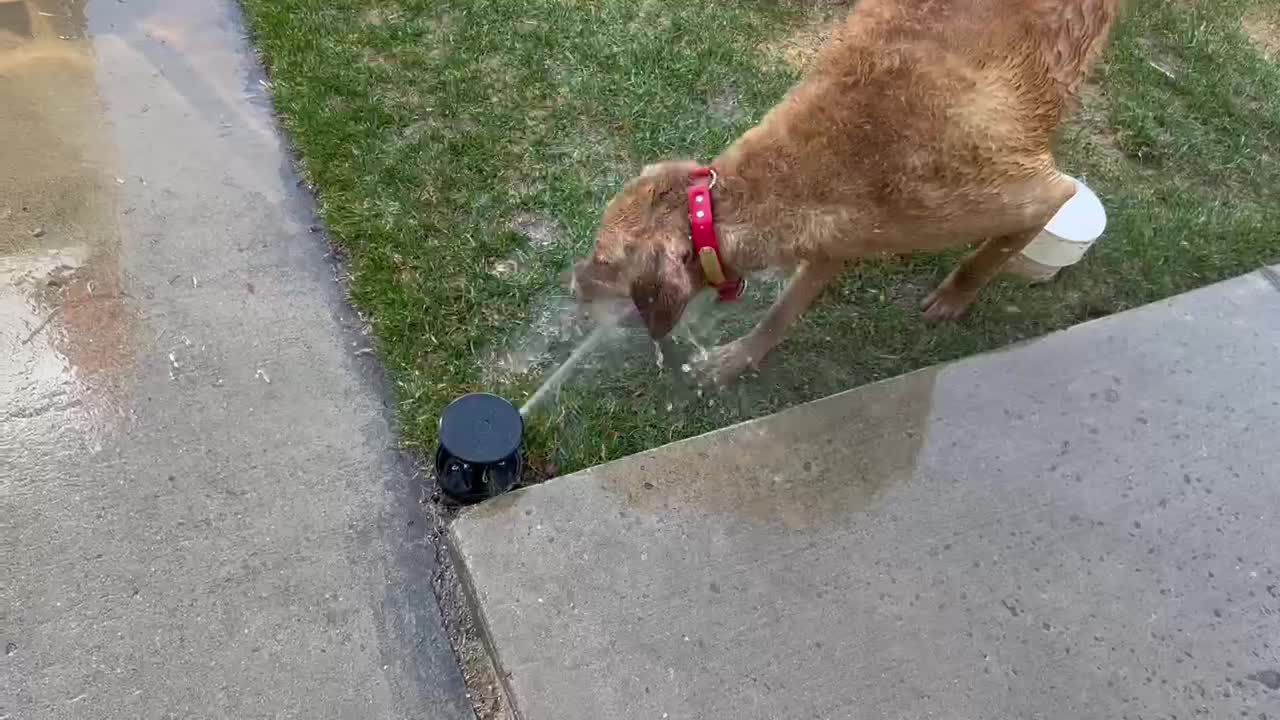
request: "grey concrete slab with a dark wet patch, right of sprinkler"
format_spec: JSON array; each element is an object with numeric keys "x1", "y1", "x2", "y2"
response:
[{"x1": 451, "y1": 274, "x2": 1280, "y2": 720}]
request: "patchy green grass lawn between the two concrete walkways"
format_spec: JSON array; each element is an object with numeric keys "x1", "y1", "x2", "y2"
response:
[{"x1": 244, "y1": 0, "x2": 1280, "y2": 479}]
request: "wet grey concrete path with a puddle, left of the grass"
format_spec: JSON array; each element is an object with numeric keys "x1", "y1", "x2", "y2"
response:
[{"x1": 0, "y1": 0, "x2": 470, "y2": 720}]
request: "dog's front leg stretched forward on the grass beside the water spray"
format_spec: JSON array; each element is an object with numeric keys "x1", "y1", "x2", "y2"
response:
[{"x1": 699, "y1": 260, "x2": 846, "y2": 384}]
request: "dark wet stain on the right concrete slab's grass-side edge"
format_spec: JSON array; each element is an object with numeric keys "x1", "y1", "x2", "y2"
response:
[{"x1": 593, "y1": 369, "x2": 937, "y2": 529}]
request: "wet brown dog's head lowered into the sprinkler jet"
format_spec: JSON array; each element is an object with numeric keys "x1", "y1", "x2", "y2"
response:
[{"x1": 571, "y1": 161, "x2": 705, "y2": 340}]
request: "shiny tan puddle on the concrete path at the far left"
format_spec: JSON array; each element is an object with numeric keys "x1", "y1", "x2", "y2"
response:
[{"x1": 0, "y1": 0, "x2": 131, "y2": 481}]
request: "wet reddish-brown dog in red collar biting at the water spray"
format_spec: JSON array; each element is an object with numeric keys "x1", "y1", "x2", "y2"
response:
[{"x1": 573, "y1": 0, "x2": 1120, "y2": 383}]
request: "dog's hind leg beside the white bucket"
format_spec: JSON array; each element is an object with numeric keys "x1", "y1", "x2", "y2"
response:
[{"x1": 922, "y1": 174, "x2": 1075, "y2": 322}]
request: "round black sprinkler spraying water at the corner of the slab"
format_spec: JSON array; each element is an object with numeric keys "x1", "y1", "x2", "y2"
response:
[{"x1": 435, "y1": 392, "x2": 525, "y2": 503}]
